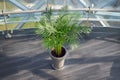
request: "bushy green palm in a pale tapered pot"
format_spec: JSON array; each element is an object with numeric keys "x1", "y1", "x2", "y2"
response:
[{"x1": 36, "y1": 9, "x2": 90, "y2": 70}]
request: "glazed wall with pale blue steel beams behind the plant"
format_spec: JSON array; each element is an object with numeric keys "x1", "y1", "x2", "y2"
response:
[{"x1": 0, "y1": 0, "x2": 120, "y2": 29}]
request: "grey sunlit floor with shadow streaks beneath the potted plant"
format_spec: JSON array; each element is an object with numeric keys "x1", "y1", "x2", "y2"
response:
[{"x1": 0, "y1": 34, "x2": 120, "y2": 80}]
